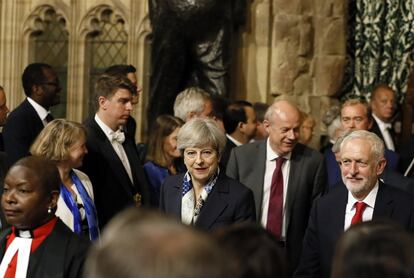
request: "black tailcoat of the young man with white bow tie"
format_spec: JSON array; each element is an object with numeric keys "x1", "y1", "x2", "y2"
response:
[{"x1": 82, "y1": 116, "x2": 149, "y2": 228}]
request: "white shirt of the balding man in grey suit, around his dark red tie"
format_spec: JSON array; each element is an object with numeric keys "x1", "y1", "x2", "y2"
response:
[{"x1": 261, "y1": 139, "x2": 291, "y2": 240}]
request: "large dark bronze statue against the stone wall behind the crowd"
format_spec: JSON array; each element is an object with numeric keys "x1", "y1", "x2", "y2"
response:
[{"x1": 148, "y1": 0, "x2": 250, "y2": 126}]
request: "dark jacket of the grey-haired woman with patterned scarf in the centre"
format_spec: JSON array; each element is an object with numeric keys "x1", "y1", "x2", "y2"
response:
[{"x1": 160, "y1": 173, "x2": 256, "y2": 230}]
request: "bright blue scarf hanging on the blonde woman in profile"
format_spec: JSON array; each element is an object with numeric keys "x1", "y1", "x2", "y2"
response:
[{"x1": 60, "y1": 171, "x2": 99, "y2": 241}]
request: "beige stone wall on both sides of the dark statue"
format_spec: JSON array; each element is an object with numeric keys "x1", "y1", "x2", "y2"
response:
[{"x1": 0, "y1": 0, "x2": 347, "y2": 143}]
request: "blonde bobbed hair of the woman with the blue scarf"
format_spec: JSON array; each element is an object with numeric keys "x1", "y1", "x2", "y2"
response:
[{"x1": 30, "y1": 119, "x2": 86, "y2": 162}]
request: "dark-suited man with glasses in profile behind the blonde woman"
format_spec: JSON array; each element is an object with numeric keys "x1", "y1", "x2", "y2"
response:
[{"x1": 3, "y1": 63, "x2": 62, "y2": 165}]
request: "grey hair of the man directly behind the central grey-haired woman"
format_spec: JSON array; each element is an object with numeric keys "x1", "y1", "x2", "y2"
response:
[{"x1": 174, "y1": 87, "x2": 210, "y2": 121}]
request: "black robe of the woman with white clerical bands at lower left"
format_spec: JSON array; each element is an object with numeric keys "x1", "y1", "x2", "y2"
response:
[{"x1": 0, "y1": 220, "x2": 89, "y2": 278}]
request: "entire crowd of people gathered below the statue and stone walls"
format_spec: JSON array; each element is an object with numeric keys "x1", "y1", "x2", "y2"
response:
[{"x1": 0, "y1": 63, "x2": 414, "y2": 278}]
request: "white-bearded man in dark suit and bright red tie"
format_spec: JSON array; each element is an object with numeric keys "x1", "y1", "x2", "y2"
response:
[{"x1": 295, "y1": 130, "x2": 414, "y2": 278}]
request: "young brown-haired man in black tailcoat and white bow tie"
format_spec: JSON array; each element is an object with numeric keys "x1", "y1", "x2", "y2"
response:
[{"x1": 83, "y1": 74, "x2": 149, "y2": 228}]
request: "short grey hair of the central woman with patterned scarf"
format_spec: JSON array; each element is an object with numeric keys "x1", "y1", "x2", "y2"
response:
[{"x1": 177, "y1": 118, "x2": 226, "y2": 155}]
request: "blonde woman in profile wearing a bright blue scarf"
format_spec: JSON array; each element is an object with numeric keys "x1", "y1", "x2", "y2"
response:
[{"x1": 30, "y1": 119, "x2": 99, "y2": 240}]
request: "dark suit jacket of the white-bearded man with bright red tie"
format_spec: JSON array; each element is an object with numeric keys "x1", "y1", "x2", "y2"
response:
[{"x1": 295, "y1": 182, "x2": 414, "y2": 277}]
